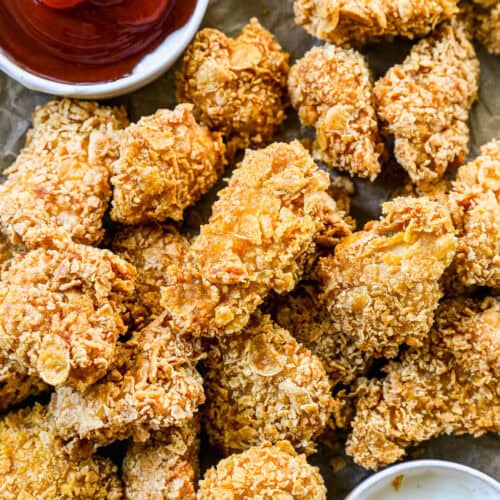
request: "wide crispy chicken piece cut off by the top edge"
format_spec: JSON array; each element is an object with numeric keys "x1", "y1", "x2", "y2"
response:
[{"x1": 294, "y1": 0, "x2": 458, "y2": 47}]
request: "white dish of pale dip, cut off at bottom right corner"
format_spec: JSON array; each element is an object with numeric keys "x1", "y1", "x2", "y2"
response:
[{"x1": 346, "y1": 460, "x2": 500, "y2": 500}]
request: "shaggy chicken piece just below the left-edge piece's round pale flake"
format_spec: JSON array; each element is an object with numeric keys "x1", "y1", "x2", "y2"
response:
[{"x1": 50, "y1": 316, "x2": 205, "y2": 448}]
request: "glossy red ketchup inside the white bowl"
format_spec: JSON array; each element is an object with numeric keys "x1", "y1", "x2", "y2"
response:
[{"x1": 0, "y1": 0, "x2": 196, "y2": 83}]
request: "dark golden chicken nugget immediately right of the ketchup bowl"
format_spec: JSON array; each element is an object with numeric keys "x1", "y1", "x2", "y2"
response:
[{"x1": 177, "y1": 18, "x2": 289, "y2": 153}]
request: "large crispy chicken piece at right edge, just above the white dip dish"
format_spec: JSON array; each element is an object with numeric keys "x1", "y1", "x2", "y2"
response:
[{"x1": 347, "y1": 297, "x2": 500, "y2": 469}]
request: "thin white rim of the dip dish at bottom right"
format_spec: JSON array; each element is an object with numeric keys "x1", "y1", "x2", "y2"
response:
[{"x1": 345, "y1": 459, "x2": 500, "y2": 500}]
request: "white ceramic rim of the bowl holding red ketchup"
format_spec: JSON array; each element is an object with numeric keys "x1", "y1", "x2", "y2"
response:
[{"x1": 0, "y1": 0, "x2": 208, "y2": 99}]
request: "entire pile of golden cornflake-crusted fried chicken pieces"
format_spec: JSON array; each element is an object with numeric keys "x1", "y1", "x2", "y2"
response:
[{"x1": 0, "y1": 0, "x2": 500, "y2": 500}]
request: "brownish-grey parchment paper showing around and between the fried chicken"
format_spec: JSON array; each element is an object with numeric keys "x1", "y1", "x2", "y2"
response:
[{"x1": 0, "y1": 0, "x2": 500, "y2": 499}]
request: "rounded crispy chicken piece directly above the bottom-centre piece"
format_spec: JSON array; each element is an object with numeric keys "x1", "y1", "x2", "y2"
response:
[{"x1": 203, "y1": 315, "x2": 335, "y2": 455}]
